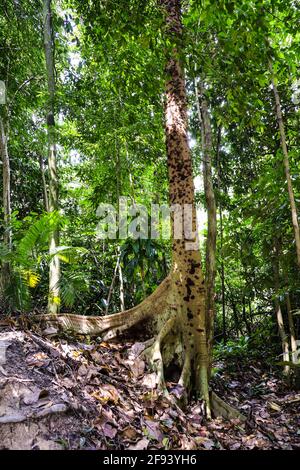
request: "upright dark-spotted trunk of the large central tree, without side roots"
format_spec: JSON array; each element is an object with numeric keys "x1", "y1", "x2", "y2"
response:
[{"x1": 161, "y1": 0, "x2": 208, "y2": 402}]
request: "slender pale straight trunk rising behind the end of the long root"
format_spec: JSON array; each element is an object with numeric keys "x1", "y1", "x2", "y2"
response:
[{"x1": 43, "y1": 0, "x2": 60, "y2": 314}]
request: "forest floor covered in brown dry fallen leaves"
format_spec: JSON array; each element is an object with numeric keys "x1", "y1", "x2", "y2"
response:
[{"x1": 0, "y1": 328, "x2": 300, "y2": 450}]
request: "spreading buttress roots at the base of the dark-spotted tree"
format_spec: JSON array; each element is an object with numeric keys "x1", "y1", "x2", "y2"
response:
[{"x1": 3, "y1": 274, "x2": 210, "y2": 418}]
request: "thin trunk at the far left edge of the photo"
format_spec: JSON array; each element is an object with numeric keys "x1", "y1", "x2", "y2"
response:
[{"x1": 0, "y1": 117, "x2": 12, "y2": 291}]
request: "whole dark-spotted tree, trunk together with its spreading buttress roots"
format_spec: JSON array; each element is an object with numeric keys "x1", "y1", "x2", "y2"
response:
[{"x1": 38, "y1": 0, "x2": 210, "y2": 416}]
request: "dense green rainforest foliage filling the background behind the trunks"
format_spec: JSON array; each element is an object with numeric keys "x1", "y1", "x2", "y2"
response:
[{"x1": 0, "y1": 0, "x2": 300, "y2": 368}]
